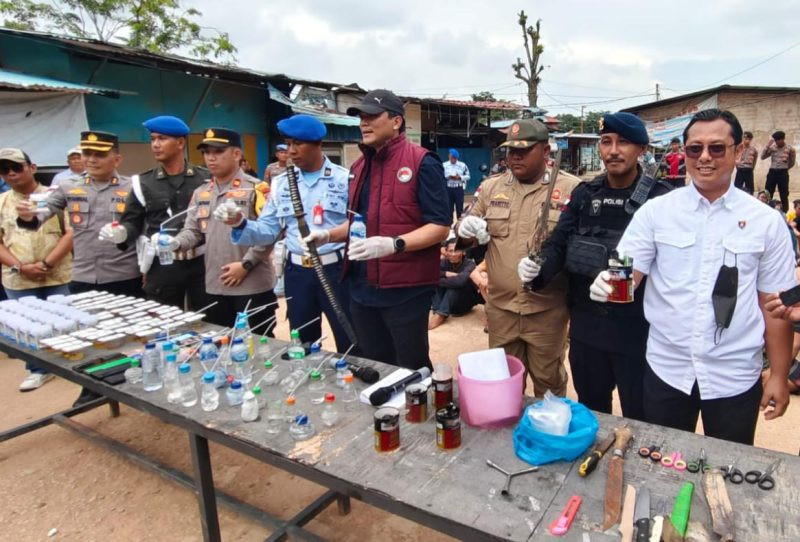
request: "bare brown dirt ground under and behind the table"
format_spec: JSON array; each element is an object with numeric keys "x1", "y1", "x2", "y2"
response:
[{"x1": 0, "y1": 300, "x2": 800, "y2": 542}]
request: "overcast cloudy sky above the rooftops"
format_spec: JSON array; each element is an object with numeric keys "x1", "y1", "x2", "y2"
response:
[{"x1": 192, "y1": 0, "x2": 800, "y2": 114}]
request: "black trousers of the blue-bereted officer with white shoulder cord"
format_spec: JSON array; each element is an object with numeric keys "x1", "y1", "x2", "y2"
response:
[{"x1": 144, "y1": 256, "x2": 209, "y2": 312}]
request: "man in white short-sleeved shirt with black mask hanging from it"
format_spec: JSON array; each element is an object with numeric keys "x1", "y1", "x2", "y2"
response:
[{"x1": 590, "y1": 109, "x2": 796, "y2": 444}]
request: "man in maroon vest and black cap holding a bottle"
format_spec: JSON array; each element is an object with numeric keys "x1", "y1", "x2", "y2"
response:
[{"x1": 304, "y1": 90, "x2": 452, "y2": 369}]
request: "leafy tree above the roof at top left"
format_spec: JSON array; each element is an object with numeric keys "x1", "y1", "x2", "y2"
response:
[{"x1": 0, "y1": 0, "x2": 236, "y2": 62}]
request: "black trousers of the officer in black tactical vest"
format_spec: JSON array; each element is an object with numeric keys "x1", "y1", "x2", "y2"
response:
[{"x1": 569, "y1": 338, "x2": 647, "y2": 420}]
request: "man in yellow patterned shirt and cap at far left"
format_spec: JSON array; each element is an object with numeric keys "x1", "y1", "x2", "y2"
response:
[{"x1": 0, "y1": 148, "x2": 72, "y2": 391}]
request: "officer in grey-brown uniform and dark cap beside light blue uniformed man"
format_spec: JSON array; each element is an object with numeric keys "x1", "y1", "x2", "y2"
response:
[{"x1": 159, "y1": 128, "x2": 276, "y2": 332}]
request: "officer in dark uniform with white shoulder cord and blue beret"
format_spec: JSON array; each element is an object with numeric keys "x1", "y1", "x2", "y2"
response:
[{"x1": 100, "y1": 116, "x2": 211, "y2": 309}]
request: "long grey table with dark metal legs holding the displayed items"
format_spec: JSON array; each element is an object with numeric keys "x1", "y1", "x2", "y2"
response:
[{"x1": 0, "y1": 332, "x2": 800, "y2": 542}]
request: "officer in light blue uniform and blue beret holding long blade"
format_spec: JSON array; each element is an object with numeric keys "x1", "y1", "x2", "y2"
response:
[{"x1": 226, "y1": 115, "x2": 350, "y2": 352}]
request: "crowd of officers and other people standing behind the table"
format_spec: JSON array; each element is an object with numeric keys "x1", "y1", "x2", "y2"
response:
[{"x1": 0, "y1": 90, "x2": 800, "y2": 443}]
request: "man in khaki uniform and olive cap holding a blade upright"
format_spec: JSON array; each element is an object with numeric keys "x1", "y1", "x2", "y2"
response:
[{"x1": 457, "y1": 119, "x2": 580, "y2": 397}]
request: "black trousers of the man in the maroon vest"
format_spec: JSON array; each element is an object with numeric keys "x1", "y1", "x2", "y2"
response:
[{"x1": 350, "y1": 294, "x2": 432, "y2": 370}]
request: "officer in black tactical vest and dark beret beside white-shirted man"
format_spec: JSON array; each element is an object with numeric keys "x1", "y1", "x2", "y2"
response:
[{"x1": 518, "y1": 113, "x2": 672, "y2": 420}]
